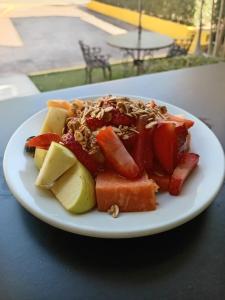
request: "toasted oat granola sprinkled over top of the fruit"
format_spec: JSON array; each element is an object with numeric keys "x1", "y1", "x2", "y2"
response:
[{"x1": 62, "y1": 95, "x2": 167, "y2": 154}]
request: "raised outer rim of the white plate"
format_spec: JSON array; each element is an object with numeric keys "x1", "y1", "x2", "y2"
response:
[{"x1": 3, "y1": 93, "x2": 225, "y2": 238}]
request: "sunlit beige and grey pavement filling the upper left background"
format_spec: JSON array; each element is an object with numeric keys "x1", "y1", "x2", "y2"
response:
[{"x1": 0, "y1": 0, "x2": 133, "y2": 100}]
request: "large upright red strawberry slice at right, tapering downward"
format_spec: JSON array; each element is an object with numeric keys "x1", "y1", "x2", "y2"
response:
[{"x1": 153, "y1": 122, "x2": 188, "y2": 174}]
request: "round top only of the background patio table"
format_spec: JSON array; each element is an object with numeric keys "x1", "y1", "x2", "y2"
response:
[{"x1": 107, "y1": 30, "x2": 174, "y2": 50}]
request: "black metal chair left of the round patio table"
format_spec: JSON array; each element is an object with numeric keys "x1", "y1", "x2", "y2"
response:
[{"x1": 79, "y1": 41, "x2": 112, "y2": 83}]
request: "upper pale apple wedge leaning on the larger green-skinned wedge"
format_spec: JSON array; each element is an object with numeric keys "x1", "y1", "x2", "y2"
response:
[{"x1": 35, "y1": 142, "x2": 77, "y2": 188}]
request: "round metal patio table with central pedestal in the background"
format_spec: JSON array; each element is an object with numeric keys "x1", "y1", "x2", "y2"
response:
[{"x1": 107, "y1": 30, "x2": 174, "y2": 74}]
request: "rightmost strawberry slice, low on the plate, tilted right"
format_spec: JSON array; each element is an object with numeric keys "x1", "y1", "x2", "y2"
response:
[{"x1": 169, "y1": 153, "x2": 199, "y2": 196}]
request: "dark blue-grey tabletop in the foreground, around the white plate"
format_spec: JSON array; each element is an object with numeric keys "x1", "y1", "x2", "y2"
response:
[{"x1": 0, "y1": 63, "x2": 225, "y2": 300}]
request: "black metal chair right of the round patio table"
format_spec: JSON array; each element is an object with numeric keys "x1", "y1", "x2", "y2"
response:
[{"x1": 167, "y1": 34, "x2": 194, "y2": 57}]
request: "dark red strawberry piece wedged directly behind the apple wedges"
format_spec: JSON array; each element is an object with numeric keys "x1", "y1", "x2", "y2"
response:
[{"x1": 61, "y1": 131, "x2": 102, "y2": 175}]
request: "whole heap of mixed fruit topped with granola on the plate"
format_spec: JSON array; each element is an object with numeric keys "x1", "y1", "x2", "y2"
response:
[{"x1": 25, "y1": 95, "x2": 199, "y2": 217}]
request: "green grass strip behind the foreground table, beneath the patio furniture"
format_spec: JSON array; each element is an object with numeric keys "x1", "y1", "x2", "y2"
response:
[{"x1": 29, "y1": 56, "x2": 221, "y2": 92}]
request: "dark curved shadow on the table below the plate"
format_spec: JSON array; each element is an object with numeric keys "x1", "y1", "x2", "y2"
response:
[{"x1": 18, "y1": 204, "x2": 208, "y2": 281}]
